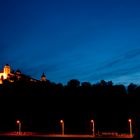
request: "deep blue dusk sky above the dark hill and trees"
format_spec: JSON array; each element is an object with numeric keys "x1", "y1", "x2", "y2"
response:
[{"x1": 0, "y1": 0, "x2": 140, "y2": 85}]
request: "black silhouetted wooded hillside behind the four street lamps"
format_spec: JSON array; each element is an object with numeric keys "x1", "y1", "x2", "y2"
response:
[{"x1": 0, "y1": 76, "x2": 140, "y2": 135}]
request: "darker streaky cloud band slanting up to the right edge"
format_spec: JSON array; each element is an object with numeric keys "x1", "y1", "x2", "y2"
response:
[{"x1": 82, "y1": 49, "x2": 140, "y2": 80}]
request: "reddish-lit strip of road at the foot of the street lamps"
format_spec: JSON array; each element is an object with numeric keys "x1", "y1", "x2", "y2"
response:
[{"x1": 0, "y1": 133, "x2": 133, "y2": 140}]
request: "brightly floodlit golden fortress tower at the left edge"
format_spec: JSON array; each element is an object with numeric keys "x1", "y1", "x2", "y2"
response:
[{"x1": 0, "y1": 64, "x2": 11, "y2": 84}]
